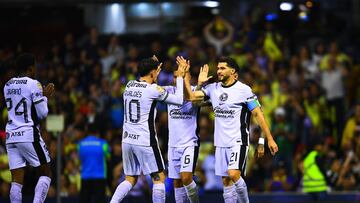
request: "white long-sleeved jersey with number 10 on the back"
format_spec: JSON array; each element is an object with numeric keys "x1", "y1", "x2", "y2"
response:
[{"x1": 122, "y1": 77, "x2": 184, "y2": 146}]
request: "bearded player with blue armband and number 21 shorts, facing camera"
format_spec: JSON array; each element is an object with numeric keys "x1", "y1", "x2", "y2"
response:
[{"x1": 186, "y1": 57, "x2": 278, "y2": 202}]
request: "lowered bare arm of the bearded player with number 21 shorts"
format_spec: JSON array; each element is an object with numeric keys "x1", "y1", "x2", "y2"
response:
[{"x1": 251, "y1": 107, "x2": 279, "y2": 157}]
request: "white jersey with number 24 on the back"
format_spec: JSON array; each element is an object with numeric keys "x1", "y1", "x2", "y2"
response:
[{"x1": 4, "y1": 77, "x2": 48, "y2": 144}]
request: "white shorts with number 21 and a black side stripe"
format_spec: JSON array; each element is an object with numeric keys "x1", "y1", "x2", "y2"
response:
[{"x1": 215, "y1": 145, "x2": 249, "y2": 176}]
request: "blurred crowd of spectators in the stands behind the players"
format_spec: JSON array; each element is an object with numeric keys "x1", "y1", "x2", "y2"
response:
[{"x1": 0, "y1": 10, "x2": 360, "y2": 197}]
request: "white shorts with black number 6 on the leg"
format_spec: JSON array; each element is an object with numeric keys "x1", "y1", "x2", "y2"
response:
[{"x1": 168, "y1": 146, "x2": 199, "y2": 179}]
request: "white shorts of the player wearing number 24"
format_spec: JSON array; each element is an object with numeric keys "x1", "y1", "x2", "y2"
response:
[{"x1": 6, "y1": 140, "x2": 51, "y2": 170}]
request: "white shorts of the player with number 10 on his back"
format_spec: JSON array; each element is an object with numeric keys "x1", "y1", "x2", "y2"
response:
[{"x1": 122, "y1": 143, "x2": 165, "y2": 176}]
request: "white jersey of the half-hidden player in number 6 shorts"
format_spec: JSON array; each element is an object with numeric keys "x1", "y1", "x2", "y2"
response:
[{"x1": 165, "y1": 86, "x2": 200, "y2": 147}]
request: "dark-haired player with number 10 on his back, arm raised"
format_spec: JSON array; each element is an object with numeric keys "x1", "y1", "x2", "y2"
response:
[{"x1": 111, "y1": 57, "x2": 185, "y2": 203}]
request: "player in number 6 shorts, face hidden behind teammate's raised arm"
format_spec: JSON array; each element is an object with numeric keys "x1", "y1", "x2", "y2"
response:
[{"x1": 164, "y1": 57, "x2": 200, "y2": 203}]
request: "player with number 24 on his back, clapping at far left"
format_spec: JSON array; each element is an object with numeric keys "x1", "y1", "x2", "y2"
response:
[{"x1": 4, "y1": 54, "x2": 54, "y2": 203}]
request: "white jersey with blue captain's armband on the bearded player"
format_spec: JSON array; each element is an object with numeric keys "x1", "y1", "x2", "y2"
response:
[{"x1": 203, "y1": 81, "x2": 260, "y2": 147}]
